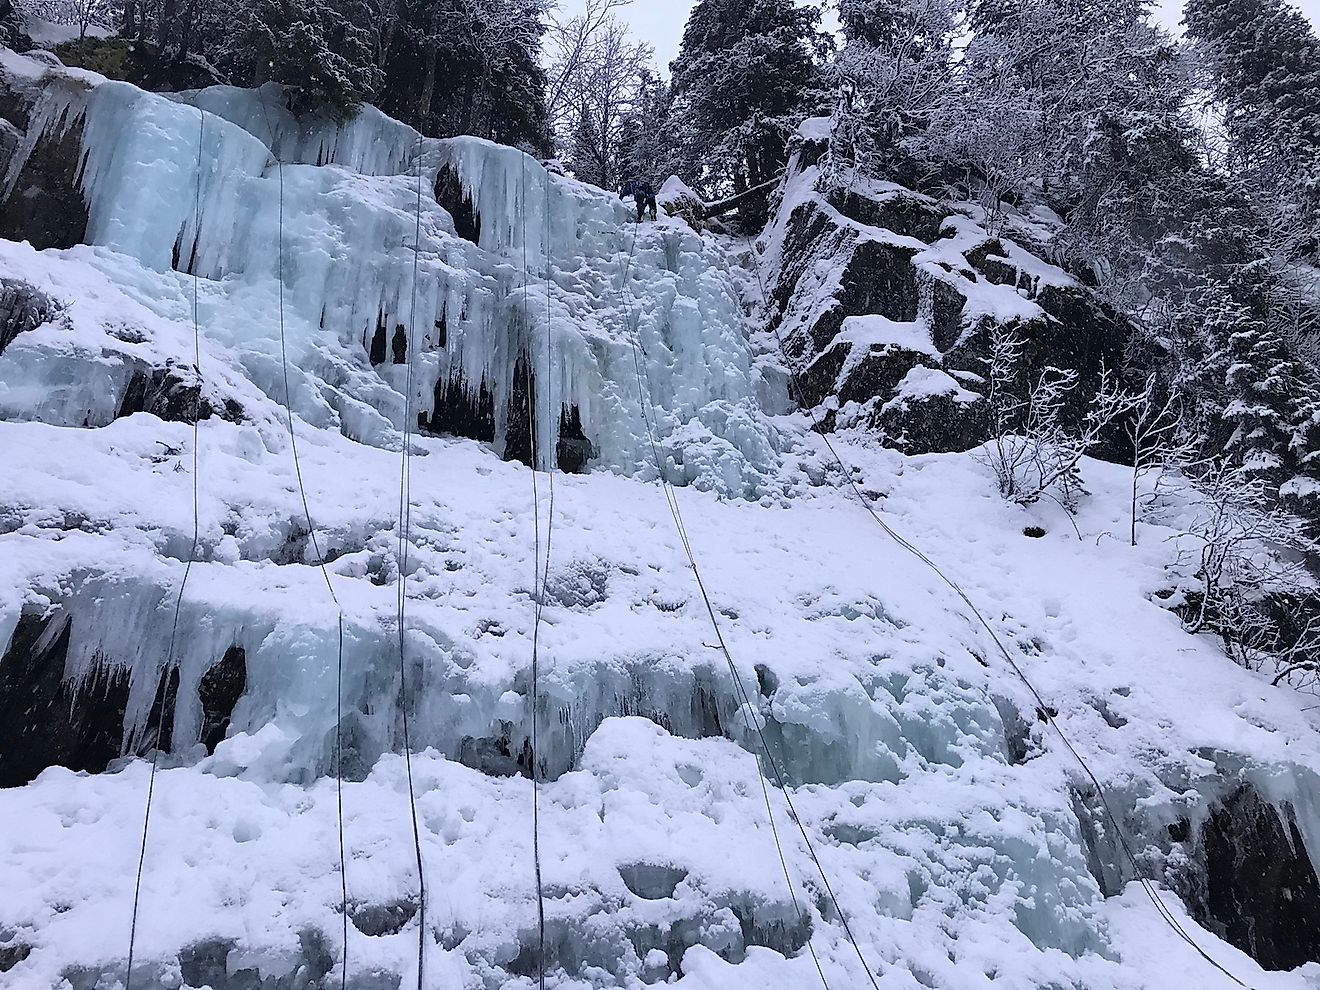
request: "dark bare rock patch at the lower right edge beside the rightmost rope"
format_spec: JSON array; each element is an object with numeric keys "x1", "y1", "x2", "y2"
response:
[{"x1": 1199, "y1": 784, "x2": 1320, "y2": 969}]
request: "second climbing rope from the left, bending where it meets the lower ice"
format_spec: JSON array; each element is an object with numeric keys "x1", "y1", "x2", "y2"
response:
[{"x1": 249, "y1": 99, "x2": 348, "y2": 990}]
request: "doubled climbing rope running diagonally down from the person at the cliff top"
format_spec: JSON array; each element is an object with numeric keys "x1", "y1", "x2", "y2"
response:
[{"x1": 620, "y1": 222, "x2": 879, "y2": 990}]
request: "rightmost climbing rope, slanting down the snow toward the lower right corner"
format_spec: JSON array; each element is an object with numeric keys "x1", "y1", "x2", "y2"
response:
[{"x1": 743, "y1": 235, "x2": 1250, "y2": 990}]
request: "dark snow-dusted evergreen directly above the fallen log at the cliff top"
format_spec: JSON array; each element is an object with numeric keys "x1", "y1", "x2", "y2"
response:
[{"x1": 672, "y1": 0, "x2": 820, "y2": 205}]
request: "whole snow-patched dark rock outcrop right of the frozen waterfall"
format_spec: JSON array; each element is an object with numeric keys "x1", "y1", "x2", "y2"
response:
[{"x1": 770, "y1": 121, "x2": 1130, "y2": 454}]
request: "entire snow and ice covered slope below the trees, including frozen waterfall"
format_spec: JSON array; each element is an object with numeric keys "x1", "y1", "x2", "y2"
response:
[{"x1": 0, "y1": 54, "x2": 1320, "y2": 990}]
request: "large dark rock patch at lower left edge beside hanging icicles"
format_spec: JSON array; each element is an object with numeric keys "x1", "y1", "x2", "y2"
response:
[{"x1": 0, "y1": 611, "x2": 129, "y2": 787}]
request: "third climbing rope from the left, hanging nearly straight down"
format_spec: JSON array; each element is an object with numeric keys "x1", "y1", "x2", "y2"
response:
[{"x1": 396, "y1": 131, "x2": 426, "y2": 990}]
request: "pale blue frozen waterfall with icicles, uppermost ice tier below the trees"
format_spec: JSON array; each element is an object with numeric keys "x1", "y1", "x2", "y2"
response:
[{"x1": 7, "y1": 66, "x2": 779, "y2": 498}]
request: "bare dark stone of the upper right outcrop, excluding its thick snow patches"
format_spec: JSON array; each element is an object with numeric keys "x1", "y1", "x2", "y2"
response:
[{"x1": 771, "y1": 161, "x2": 1131, "y2": 455}]
